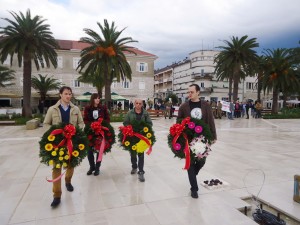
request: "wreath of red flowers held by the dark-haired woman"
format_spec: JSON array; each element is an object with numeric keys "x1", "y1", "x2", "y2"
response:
[{"x1": 84, "y1": 118, "x2": 116, "y2": 161}]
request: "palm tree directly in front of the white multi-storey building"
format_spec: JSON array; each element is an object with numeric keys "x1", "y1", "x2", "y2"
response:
[{"x1": 215, "y1": 35, "x2": 259, "y2": 101}]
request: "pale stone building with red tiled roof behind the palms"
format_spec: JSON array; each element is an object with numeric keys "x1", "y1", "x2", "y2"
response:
[{"x1": 0, "y1": 40, "x2": 157, "y2": 108}]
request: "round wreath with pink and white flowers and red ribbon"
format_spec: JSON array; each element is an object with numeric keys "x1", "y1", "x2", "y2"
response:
[{"x1": 168, "y1": 117, "x2": 213, "y2": 169}]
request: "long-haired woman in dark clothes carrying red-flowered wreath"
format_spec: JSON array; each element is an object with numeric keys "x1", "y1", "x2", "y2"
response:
[{"x1": 83, "y1": 93, "x2": 110, "y2": 176}]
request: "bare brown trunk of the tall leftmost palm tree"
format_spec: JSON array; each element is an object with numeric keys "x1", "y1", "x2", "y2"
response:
[{"x1": 22, "y1": 51, "x2": 32, "y2": 118}]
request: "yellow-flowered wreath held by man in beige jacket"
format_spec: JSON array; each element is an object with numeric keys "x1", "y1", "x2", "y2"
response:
[{"x1": 39, "y1": 124, "x2": 89, "y2": 169}]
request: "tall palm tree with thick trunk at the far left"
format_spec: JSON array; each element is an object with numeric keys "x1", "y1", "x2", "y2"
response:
[{"x1": 0, "y1": 10, "x2": 58, "y2": 117}]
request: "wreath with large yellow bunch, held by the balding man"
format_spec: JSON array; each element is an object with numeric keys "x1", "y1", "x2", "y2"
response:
[{"x1": 118, "y1": 121, "x2": 156, "y2": 155}]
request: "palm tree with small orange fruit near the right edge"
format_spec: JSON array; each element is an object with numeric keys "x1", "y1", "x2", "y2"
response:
[{"x1": 263, "y1": 48, "x2": 300, "y2": 114}]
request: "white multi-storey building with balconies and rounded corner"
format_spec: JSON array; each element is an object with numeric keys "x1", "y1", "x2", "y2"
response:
[{"x1": 154, "y1": 50, "x2": 270, "y2": 102}]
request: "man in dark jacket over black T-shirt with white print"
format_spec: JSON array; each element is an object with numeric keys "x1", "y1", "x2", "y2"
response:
[{"x1": 177, "y1": 84, "x2": 217, "y2": 198}]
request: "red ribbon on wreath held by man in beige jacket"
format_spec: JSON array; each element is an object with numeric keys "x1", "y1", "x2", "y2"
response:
[{"x1": 46, "y1": 124, "x2": 76, "y2": 182}]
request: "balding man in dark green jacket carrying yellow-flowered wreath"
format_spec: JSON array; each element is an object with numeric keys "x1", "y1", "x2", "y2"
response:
[{"x1": 123, "y1": 99, "x2": 153, "y2": 182}]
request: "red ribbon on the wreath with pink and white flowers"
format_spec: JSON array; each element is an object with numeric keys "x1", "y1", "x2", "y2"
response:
[{"x1": 170, "y1": 117, "x2": 191, "y2": 170}]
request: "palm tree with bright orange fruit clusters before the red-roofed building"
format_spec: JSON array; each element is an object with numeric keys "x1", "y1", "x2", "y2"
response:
[{"x1": 77, "y1": 19, "x2": 137, "y2": 107}]
